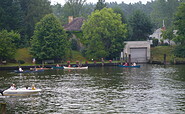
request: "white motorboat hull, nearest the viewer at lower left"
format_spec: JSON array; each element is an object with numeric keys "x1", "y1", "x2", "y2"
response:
[{"x1": 3, "y1": 88, "x2": 42, "y2": 96}]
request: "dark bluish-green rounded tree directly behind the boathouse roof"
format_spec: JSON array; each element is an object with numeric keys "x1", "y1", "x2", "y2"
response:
[{"x1": 129, "y1": 10, "x2": 153, "y2": 41}]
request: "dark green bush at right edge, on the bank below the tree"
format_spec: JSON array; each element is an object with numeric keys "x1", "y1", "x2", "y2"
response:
[{"x1": 173, "y1": 45, "x2": 185, "y2": 58}]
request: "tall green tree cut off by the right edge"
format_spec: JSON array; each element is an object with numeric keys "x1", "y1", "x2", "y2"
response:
[{"x1": 174, "y1": 3, "x2": 185, "y2": 44}]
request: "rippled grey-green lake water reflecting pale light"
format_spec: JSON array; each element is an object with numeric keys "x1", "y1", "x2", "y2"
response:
[{"x1": 0, "y1": 65, "x2": 185, "y2": 114}]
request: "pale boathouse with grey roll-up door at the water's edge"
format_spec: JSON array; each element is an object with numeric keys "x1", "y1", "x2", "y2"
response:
[{"x1": 123, "y1": 41, "x2": 150, "y2": 63}]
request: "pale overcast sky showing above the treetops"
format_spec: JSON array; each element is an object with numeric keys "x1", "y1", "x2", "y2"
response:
[{"x1": 50, "y1": 0, "x2": 151, "y2": 5}]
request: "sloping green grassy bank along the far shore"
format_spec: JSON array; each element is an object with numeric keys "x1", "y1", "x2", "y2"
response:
[{"x1": 0, "y1": 46, "x2": 185, "y2": 67}]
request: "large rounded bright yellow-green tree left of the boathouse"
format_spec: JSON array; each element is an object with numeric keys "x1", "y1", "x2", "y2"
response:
[{"x1": 81, "y1": 8, "x2": 127, "y2": 59}]
